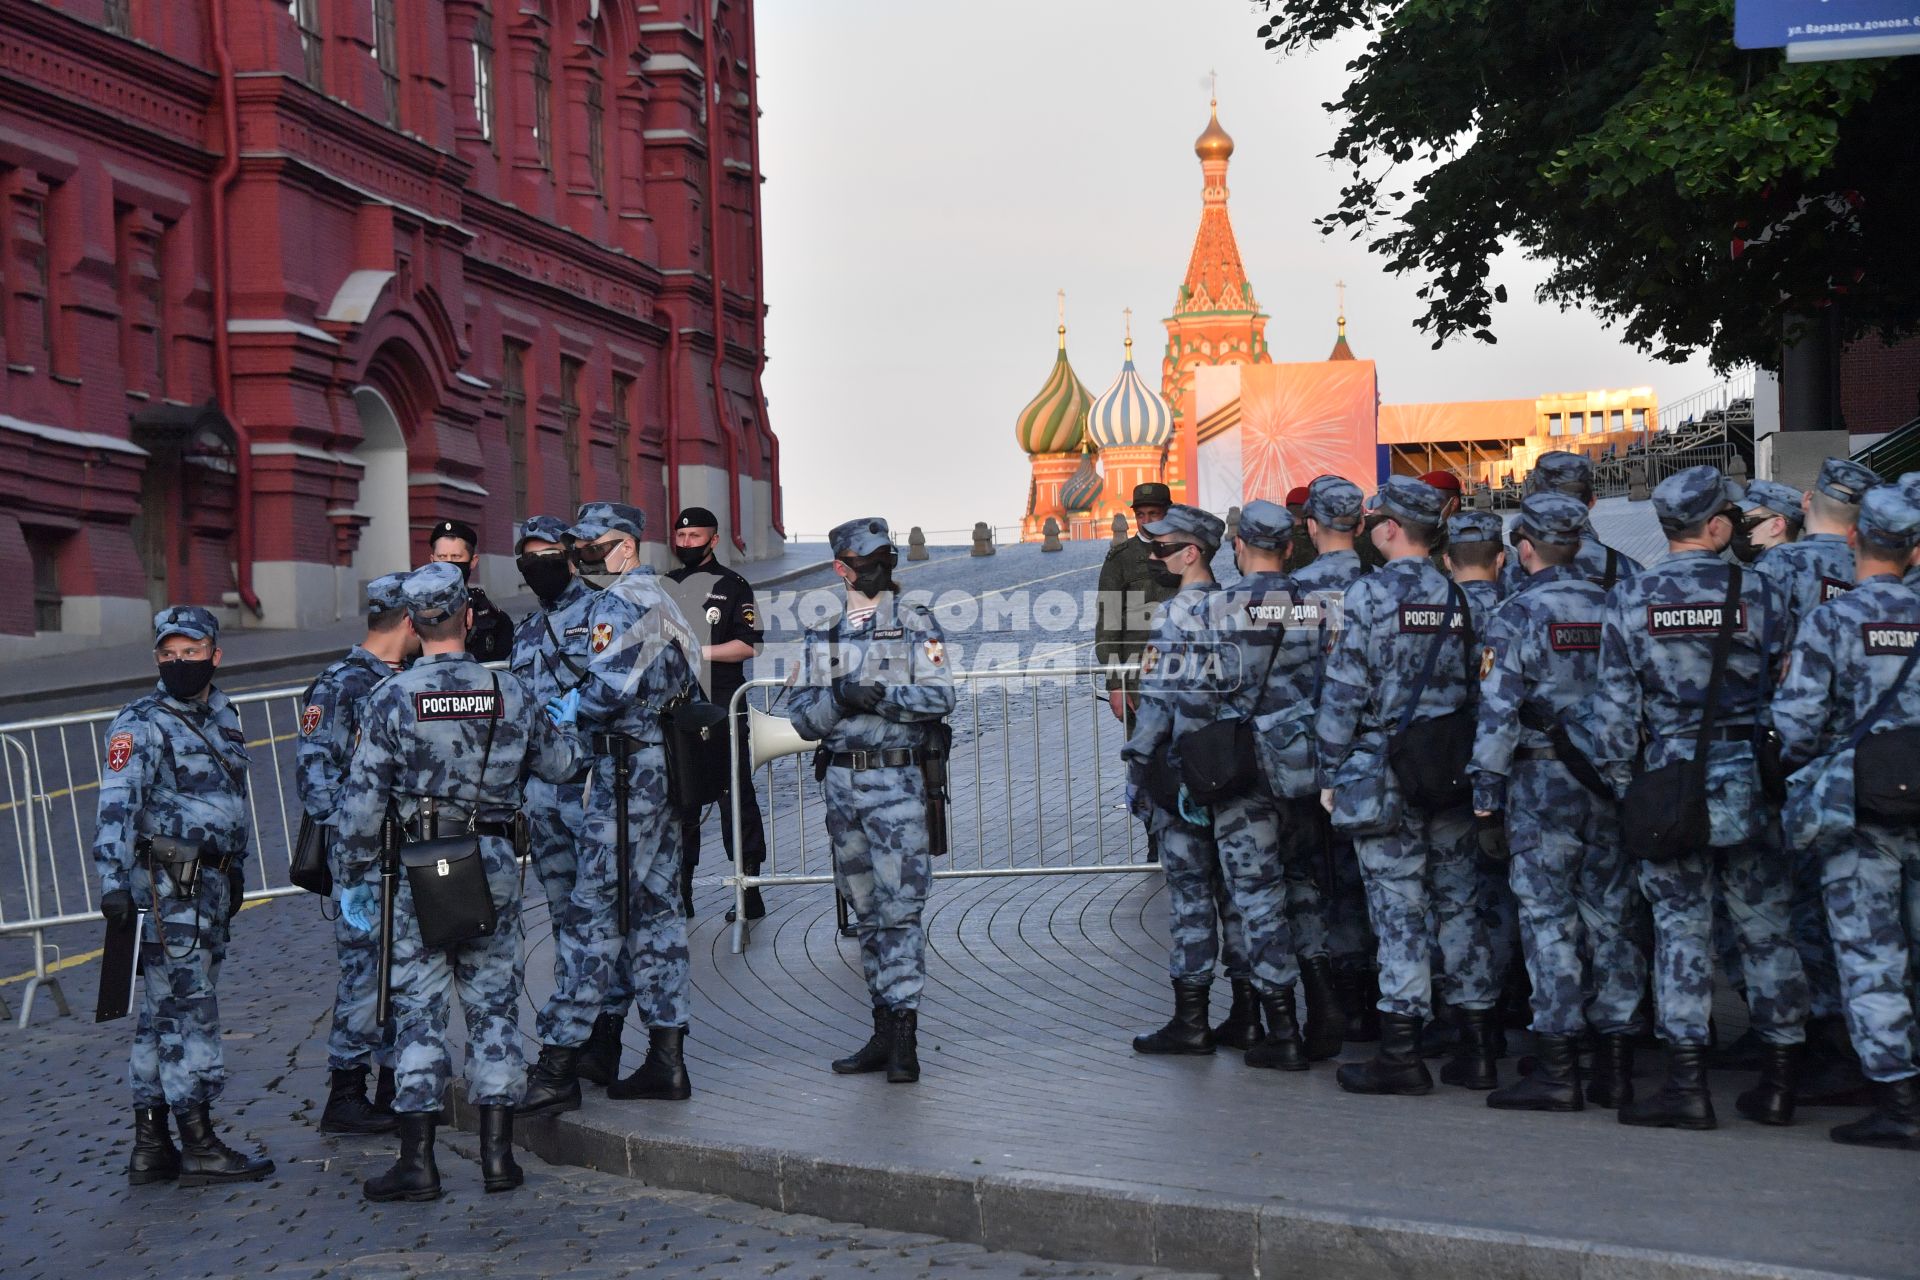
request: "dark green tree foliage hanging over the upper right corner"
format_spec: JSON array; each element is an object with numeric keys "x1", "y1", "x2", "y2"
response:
[{"x1": 1258, "y1": 0, "x2": 1920, "y2": 368}]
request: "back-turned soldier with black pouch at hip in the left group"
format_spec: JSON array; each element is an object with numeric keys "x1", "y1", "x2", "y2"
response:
[{"x1": 340, "y1": 564, "x2": 580, "y2": 1201}]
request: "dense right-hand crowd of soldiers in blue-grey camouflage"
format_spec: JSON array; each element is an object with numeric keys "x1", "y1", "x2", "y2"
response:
[{"x1": 1096, "y1": 453, "x2": 1920, "y2": 1150}]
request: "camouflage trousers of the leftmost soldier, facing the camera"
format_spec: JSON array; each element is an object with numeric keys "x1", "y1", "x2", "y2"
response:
[{"x1": 127, "y1": 867, "x2": 228, "y2": 1111}]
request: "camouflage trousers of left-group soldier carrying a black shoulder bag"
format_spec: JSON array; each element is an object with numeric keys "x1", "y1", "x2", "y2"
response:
[{"x1": 568, "y1": 743, "x2": 691, "y2": 1044}]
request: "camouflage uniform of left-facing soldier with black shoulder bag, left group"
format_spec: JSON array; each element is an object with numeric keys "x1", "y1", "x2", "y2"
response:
[{"x1": 576, "y1": 503, "x2": 701, "y2": 1044}]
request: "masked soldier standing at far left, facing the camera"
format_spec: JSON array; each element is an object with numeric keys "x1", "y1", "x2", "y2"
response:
[{"x1": 92, "y1": 604, "x2": 273, "y2": 1186}]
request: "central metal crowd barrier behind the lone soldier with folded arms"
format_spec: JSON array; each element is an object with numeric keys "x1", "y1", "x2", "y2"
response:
[{"x1": 726, "y1": 660, "x2": 1160, "y2": 954}]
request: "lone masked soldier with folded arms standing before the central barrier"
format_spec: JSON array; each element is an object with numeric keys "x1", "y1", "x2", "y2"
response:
[{"x1": 789, "y1": 516, "x2": 954, "y2": 1084}]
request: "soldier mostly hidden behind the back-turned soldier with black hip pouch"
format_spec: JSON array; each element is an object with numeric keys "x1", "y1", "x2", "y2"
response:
[{"x1": 294, "y1": 574, "x2": 419, "y2": 1134}]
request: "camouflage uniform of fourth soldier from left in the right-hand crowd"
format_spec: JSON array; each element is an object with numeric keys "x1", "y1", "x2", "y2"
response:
[{"x1": 1315, "y1": 476, "x2": 1500, "y2": 1019}]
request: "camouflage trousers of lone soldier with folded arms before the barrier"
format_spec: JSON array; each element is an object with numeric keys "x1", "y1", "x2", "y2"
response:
[{"x1": 820, "y1": 766, "x2": 933, "y2": 1009}]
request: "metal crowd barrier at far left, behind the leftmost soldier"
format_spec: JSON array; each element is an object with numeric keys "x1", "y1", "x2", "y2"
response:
[{"x1": 0, "y1": 685, "x2": 324, "y2": 1027}]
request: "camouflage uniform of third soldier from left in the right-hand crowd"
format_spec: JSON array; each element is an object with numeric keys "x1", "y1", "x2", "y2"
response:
[{"x1": 1281, "y1": 476, "x2": 1379, "y2": 969}]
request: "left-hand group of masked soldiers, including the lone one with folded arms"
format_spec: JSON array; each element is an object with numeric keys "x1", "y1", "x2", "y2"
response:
[{"x1": 94, "y1": 503, "x2": 952, "y2": 1201}]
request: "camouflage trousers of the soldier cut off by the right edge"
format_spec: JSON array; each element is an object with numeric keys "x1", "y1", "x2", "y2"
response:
[{"x1": 1822, "y1": 823, "x2": 1920, "y2": 1080}]
